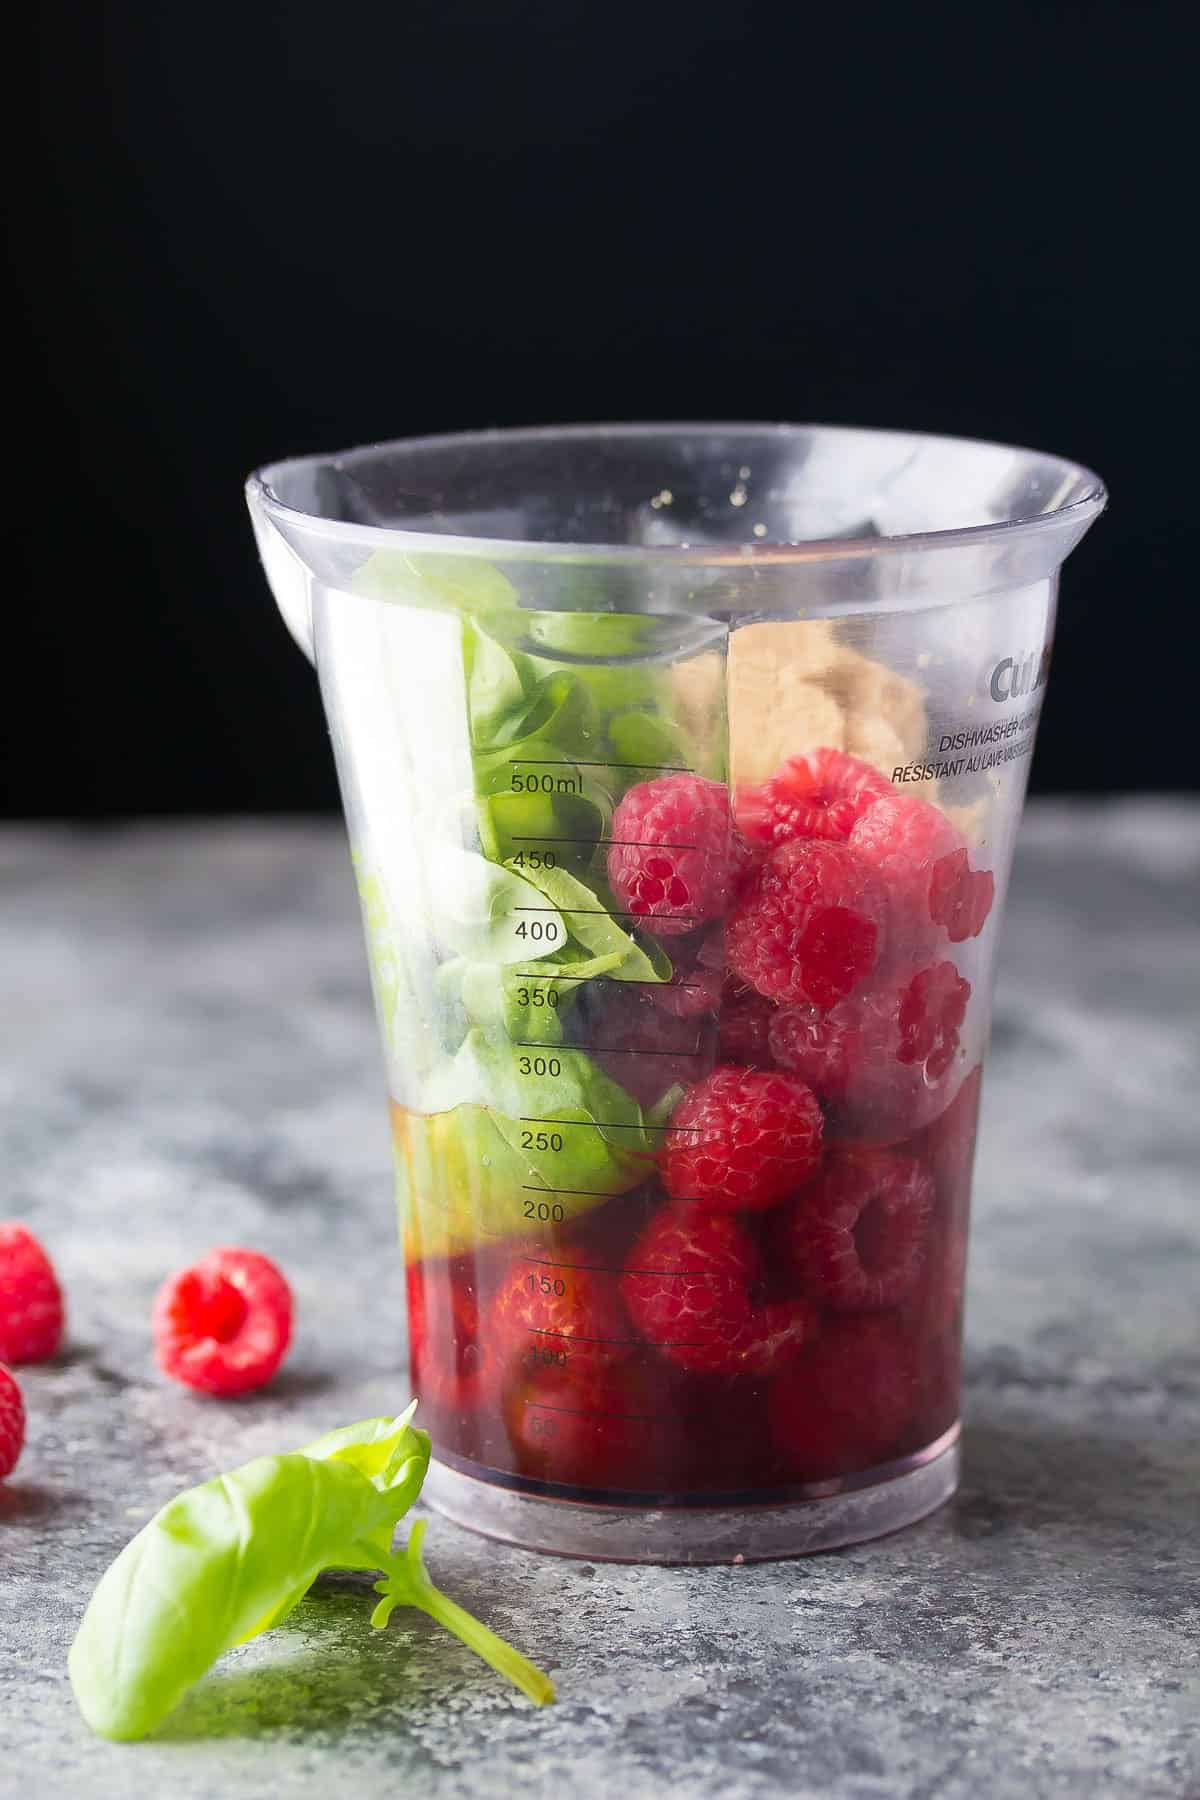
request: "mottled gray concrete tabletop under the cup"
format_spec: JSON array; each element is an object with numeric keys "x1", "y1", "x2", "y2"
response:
[{"x1": 0, "y1": 805, "x2": 1200, "y2": 1800}]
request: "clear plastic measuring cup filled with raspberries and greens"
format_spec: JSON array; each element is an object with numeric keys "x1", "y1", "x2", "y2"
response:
[{"x1": 248, "y1": 425, "x2": 1105, "y2": 1562}]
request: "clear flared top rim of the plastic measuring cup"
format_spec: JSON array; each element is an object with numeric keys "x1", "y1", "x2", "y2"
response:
[{"x1": 246, "y1": 419, "x2": 1108, "y2": 569}]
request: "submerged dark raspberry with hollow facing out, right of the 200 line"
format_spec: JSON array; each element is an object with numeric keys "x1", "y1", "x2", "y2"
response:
[{"x1": 786, "y1": 1150, "x2": 934, "y2": 1312}]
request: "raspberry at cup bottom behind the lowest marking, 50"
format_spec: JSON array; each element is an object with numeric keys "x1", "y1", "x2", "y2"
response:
[{"x1": 502, "y1": 1363, "x2": 687, "y2": 1492}]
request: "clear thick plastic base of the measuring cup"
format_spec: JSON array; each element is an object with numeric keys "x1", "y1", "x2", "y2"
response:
[{"x1": 423, "y1": 1424, "x2": 959, "y2": 1564}]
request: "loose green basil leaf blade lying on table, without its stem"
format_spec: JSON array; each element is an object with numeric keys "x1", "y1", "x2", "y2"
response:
[{"x1": 68, "y1": 1415, "x2": 430, "y2": 1739}]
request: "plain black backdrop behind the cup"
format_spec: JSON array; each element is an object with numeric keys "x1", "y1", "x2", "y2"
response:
[{"x1": 4, "y1": 0, "x2": 1200, "y2": 817}]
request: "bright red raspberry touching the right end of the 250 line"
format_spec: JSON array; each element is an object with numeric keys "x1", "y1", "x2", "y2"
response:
[{"x1": 662, "y1": 1062, "x2": 822, "y2": 1211}]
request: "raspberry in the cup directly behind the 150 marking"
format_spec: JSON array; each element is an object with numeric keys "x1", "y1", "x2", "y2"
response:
[{"x1": 486, "y1": 1240, "x2": 637, "y2": 1377}]
